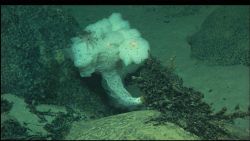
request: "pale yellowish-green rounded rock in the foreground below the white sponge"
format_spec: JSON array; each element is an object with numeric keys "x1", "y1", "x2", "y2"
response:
[{"x1": 66, "y1": 110, "x2": 199, "y2": 140}]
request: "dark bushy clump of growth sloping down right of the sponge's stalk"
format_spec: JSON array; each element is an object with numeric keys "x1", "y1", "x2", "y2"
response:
[{"x1": 125, "y1": 58, "x2": 250, "y2": 139}]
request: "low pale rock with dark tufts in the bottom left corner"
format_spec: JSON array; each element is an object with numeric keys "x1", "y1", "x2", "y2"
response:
[{"x1": 1, "y1": 94, "x2": 81, "y2": 140}]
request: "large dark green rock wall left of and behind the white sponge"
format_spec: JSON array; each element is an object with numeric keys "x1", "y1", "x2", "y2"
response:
[{"x1": 1, "y1": 6, "x2": 114, "y2": 117}]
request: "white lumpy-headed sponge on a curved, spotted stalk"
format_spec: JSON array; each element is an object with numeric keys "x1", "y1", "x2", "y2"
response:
[{"x1": 69, "y1": 13, "x2": 149, "y2": 106}]
